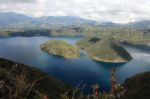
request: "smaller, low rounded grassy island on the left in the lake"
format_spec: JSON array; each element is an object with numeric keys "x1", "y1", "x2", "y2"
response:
[{"x1": 40, "y1": 40, "x2": 80, "y2": 59}]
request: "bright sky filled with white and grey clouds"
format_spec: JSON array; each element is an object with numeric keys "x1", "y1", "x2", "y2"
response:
[{"x1": 0, "y1": 0, "x2": 150, "y2": 23}]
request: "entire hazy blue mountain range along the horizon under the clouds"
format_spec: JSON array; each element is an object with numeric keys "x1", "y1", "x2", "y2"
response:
[{"x1": 0, "y1": 12, "x2": 150, "y2": 28}]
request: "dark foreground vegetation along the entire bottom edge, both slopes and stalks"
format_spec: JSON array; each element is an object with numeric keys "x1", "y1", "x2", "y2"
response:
[{"x1": 0, "y1": 58, "x2": 150, "y2": 99}]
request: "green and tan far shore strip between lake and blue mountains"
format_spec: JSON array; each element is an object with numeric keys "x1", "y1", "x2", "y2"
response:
[{"x1": 0, "y1": 25, "x2": 150, "y2": 47}]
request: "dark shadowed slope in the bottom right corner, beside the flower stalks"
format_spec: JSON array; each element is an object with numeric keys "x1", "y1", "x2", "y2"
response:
[{"x1": 122, "y1": 72, "x2": 150, "y2": 99}]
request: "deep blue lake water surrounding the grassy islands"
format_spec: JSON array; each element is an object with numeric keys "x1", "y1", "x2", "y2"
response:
[{"x1": 0, "y1": 36, "x2": 150, "y2": 92}]
